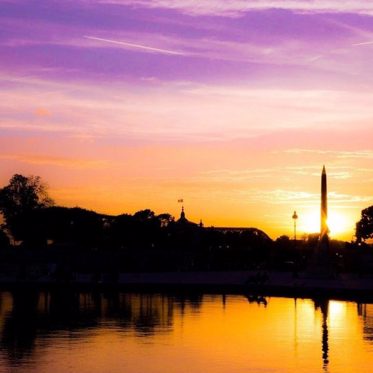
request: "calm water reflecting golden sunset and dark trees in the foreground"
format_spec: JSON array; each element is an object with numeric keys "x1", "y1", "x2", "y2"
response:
[{"x1": 0, "y1": 292, "x2": 373, "y2": 373}]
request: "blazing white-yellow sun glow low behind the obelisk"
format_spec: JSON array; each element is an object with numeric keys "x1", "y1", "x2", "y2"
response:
[{"x1": 298, "y1": 211, "x2": 353, "y2": 236}]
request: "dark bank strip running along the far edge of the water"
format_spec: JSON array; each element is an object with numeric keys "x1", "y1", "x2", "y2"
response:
[{"x1": 0, "y1": 271, "x2": 373, "y2": 301}]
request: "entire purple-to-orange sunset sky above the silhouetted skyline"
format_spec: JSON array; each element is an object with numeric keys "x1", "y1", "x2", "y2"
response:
[{"x1": 0, "y1": 0, "x2": 373, "y2": 240}]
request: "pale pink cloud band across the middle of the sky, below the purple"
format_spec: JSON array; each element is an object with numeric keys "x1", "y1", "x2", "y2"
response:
[{"x1": 0, "y1": 77, "x2": 373, "y2": 142}]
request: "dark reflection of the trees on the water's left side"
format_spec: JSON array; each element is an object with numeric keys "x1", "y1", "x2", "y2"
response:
[{"x1": 0, "y1": 291, "x2": 202, "y2": 364}]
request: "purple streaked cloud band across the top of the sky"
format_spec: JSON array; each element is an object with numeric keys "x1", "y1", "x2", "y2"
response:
[{"x1": 0, "y1": 6, "x2": 372, "y2": 86}]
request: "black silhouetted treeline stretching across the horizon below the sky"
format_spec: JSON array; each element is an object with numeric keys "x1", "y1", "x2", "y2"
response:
[{"x1": 0, "y1": 175, "x2": 373, "y2": 274}]
